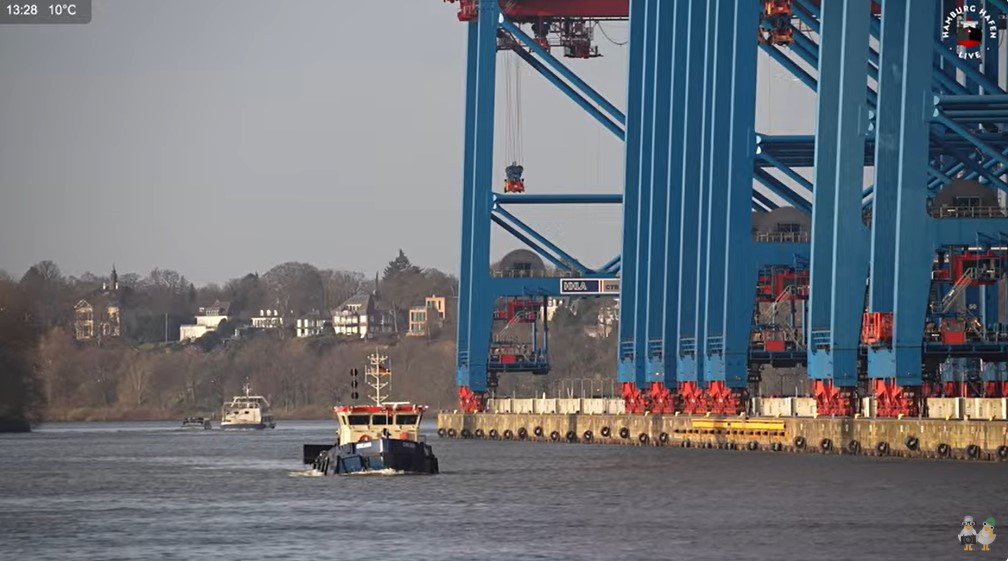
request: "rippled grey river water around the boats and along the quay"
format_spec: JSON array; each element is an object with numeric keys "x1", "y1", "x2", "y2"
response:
[{"x1": 0, "y1": 421, "x2": 1008, "y2": 561}]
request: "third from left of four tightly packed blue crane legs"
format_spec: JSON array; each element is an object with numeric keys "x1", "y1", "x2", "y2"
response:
[{"x1": 673, "y1": 2, "x2": 709, "y2": 398}]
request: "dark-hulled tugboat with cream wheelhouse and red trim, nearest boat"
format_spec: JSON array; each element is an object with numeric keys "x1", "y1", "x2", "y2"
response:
[{"x1": 302, "y1": 353, "x2": 437, "y2": 475}]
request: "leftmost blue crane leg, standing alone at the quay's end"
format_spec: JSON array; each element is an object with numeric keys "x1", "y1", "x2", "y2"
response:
[{"x1": 456, "y1": 0, "x2": 500, "y2": 404}]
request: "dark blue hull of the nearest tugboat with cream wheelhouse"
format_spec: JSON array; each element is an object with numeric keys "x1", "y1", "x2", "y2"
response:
[{"x1": 304, "y1": 438, "x2": 437, "y2": 475}]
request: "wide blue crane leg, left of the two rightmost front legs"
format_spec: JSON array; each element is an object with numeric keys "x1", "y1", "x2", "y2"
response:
[{"x1": 808, "y1": 0, "x2": 870, "y2": 414}]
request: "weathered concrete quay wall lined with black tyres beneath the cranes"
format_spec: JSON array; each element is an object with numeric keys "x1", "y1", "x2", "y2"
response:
[{"x1": 437, "y1": 404, "x2": 1008, "y2": 461}]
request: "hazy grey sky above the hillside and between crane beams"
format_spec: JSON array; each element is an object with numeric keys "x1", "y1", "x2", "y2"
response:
[{"x1": 0, "y1": 0, "x2": 814, "y2": 285}]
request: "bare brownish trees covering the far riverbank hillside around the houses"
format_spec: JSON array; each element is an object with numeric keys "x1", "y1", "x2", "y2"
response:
[{"x1": 0, "y1": 250, "x2": 616, "y2": 429}]
